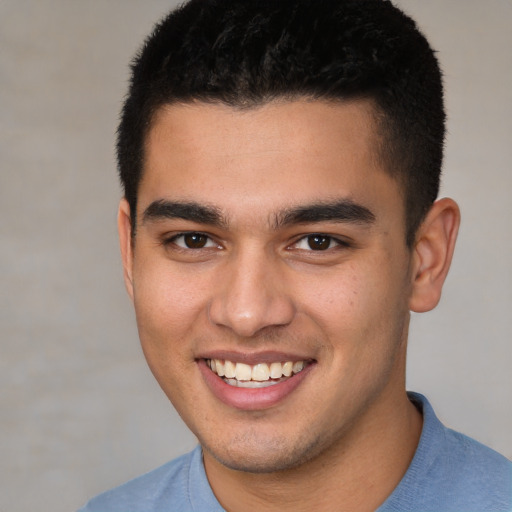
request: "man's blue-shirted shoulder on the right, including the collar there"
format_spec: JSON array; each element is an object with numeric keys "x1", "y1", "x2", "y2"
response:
[{"x1": 379, "y1": 394, "x2": 512, "y2": 512}]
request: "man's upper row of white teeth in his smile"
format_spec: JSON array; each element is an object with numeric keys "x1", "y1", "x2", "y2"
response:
[{"x1": 206, "y1": 359, "x2": 305, "y2": 382}]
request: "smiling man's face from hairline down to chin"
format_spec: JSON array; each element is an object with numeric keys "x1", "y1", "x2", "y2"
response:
[{"x1": 120, "y1": 101, "x2": 411, "y2": 472}]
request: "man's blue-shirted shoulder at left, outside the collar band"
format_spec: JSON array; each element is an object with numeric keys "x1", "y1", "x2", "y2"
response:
[{"x1": 79, "y1": 447, "x2": 209, "y2": 512}]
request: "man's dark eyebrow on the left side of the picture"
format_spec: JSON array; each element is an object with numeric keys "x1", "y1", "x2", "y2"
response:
[{"x1": 142, "y1": 199, "x2": 227, "y2": 227}]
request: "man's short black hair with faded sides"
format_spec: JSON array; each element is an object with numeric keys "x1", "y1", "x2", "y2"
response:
[{"x1": 117, "y1": 0, "x2": 445, "y2": 247}]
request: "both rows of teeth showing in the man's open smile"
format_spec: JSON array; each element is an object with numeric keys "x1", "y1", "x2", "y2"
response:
[{"x1": 206, "y1": 359, "x2": 308, "y2": 388}]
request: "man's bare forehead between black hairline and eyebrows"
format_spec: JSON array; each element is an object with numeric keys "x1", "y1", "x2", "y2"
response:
[{"x1": 139, "y1": 100, "x2": 401, "y2": 225}]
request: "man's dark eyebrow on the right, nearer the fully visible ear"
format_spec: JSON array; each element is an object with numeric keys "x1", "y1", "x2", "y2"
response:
[{"x1": 274, "y1": 199, "x2": 375, "y2": 229}]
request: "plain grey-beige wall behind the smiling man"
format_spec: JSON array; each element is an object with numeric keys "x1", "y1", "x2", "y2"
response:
[{"x1": 0, "y1": 0, "x2": 512, "y2": 512}]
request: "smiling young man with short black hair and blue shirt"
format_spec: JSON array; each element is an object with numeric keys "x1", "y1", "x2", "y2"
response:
[{"x1": 78, "y1": 0, "x2": 512, "y2": 512}]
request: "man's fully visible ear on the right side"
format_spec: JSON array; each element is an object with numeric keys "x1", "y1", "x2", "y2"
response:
[{"x1": 409, "y1": 198, "x2": 460, "y2": 313}]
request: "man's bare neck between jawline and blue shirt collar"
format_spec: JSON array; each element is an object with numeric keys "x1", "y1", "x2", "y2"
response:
[{"x1": 204, "y1": 390, "x2": 422, "y2": 512}]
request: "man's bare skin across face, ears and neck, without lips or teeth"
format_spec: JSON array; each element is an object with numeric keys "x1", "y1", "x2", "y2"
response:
[{"x1": 119, "y1": 100, "x2": 459, "y2": 511}]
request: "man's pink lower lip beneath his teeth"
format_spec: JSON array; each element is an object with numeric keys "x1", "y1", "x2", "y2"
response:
[{"x1": 197, "y1": 359, "x2": 314, "y2": 411}]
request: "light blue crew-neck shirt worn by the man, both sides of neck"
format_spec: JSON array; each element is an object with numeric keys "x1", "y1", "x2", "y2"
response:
[{"x1": 79, "y1": 393, "x2": 512, "y2": 512}]
